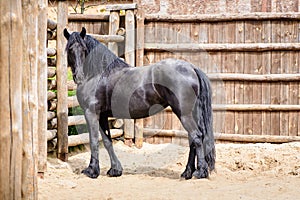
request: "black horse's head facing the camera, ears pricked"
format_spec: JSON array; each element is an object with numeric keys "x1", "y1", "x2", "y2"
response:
[{"x1": 64, "y1": 27, "x2": 88, "y2": 84}]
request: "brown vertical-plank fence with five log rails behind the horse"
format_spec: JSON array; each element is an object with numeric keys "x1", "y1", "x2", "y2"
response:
[{"x1": 144, "y1": 13, "x2": 300, "y2": 143}]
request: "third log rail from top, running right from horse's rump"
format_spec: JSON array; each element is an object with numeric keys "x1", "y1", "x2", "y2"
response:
[{"x1": 207, "y1": 73, "x2": 300, "y2": 82}]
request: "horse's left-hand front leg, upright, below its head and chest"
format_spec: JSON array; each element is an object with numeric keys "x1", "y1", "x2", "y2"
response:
[{"x1": 82, "y1": 109, "x2": 100, "y2": 178}]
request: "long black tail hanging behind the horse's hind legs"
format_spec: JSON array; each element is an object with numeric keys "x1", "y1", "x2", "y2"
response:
[{"x1": 195, "y1": 68, "x2": 216, "y2": 171}]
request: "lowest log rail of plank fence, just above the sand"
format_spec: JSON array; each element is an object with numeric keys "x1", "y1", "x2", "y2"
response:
[{"x1": 144, "y1": 128, "x2": 300, "y2": 143}]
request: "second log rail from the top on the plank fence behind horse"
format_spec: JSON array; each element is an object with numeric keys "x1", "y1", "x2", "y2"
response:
[{"x1": 145, "y1": 43, "x2": 300, "y2": 52}]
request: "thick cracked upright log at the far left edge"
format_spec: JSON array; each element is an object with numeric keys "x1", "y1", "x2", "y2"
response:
[{"x1": 0, "y1": 0, "x2": 23, "y2": 199}]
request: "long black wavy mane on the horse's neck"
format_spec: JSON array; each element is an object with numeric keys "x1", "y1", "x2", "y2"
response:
[{"x1": 66, "y1": 32, "x2": 130, "y2": 79}]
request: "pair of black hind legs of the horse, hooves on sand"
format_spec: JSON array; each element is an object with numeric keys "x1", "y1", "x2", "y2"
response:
[{"x1": 180, "y1": 116, "x2": 208, "y2": 179}]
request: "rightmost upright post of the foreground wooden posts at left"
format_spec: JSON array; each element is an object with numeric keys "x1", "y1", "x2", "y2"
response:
[{"x1": 38, "y1": 0, "x2": 48, "y2": 177}]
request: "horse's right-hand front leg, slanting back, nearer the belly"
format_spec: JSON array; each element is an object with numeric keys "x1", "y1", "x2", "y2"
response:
[{"x1": 100, "y1": 115, "x2": 123, "y2": 177}]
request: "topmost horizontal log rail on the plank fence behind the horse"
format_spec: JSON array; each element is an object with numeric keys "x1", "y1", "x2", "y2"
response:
[{"x1": 145, "y1": 12, "x2": 300, "y2": 22}]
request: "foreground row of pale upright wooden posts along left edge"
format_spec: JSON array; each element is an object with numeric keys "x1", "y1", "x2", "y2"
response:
[{"x1": 0, "y1": 0, "x2": 47, "y2": 199}]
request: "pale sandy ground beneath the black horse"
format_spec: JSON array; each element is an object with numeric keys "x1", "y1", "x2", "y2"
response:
[{"x1": 39, "y1": 142, "x2": 300, "y2": 200}]
